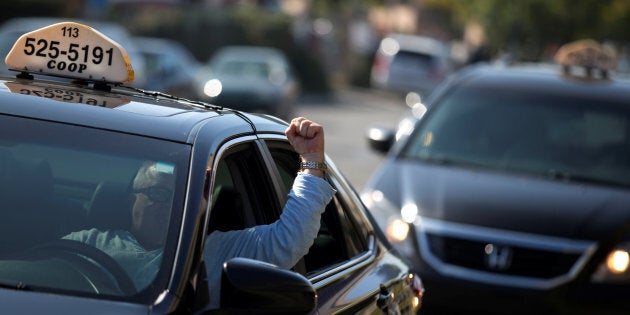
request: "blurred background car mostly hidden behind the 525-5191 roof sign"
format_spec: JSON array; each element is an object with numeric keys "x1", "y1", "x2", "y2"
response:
[{"x1": 0, "y1": 17, "x2": 147, "y2": 88}]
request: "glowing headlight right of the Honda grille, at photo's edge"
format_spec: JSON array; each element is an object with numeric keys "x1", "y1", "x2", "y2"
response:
[{"x1": 592, "y1": 241, "x2": 630, "y2": 283}]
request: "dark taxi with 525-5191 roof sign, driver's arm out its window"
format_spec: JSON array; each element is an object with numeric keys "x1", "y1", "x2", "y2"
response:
[{"x1": 0, "y1": 22, "x2": 424, "y2": 314}]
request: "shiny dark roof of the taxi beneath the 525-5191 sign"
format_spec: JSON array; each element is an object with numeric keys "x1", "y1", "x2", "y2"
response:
[{"x1": 0, "y1": 77, "x2": 286, "y2": 144}]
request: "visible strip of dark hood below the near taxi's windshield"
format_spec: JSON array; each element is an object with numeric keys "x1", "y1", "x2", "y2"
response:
[{"x1": 0, "y1": 289, "x2": 151, "y2": 315}]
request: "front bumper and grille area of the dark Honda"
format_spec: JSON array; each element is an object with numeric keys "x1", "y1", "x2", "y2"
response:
[{"x1": 400, "y1": 219, "x2": 630, "y2": 314}]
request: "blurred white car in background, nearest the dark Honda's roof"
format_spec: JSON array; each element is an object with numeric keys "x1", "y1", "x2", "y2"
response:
[{"x1": 370, "y1": 34, "x2": 453, "y2": 97}]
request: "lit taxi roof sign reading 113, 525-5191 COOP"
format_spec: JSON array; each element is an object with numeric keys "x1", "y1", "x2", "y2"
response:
[{"x1": 5, "y1": 22, "x2": 134, "y2": 83}]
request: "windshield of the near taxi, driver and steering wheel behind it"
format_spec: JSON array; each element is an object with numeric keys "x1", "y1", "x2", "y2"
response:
[{"x1": 0, "y1": 116, "x2": 190, "y2": 301}]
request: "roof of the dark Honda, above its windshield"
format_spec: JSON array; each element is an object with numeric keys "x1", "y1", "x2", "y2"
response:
[{"x1": 440, "y1": 63, "x2": 630, "y2": 104}]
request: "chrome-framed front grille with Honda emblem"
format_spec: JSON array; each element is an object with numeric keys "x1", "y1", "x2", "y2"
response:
[{"x1": 416, "y1": 218, "x2": 596, "y2": 289}]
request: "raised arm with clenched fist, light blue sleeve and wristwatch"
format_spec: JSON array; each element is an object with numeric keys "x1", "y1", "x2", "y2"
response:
[{"x1": 207, "y1": 117, "x2": 334, "y2": 267}]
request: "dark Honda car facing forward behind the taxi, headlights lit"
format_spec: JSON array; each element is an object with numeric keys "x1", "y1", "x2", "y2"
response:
[{"x1": 361, "y1": 42, "x2": 630, "y2": 314}]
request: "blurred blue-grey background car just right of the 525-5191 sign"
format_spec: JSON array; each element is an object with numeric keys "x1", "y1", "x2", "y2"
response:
[{"x1": 133, "y1": 37, "x2": 202, "y2": 99}]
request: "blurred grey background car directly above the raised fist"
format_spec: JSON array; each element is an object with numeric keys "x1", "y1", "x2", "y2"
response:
[{"x1": 200, "y1": 46, "x2": 300, "y2": 119}]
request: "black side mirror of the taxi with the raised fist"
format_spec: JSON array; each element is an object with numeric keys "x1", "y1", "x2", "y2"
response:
[{"x1": 221, "y1": 258, "x2": 317, "y2": 314}]
